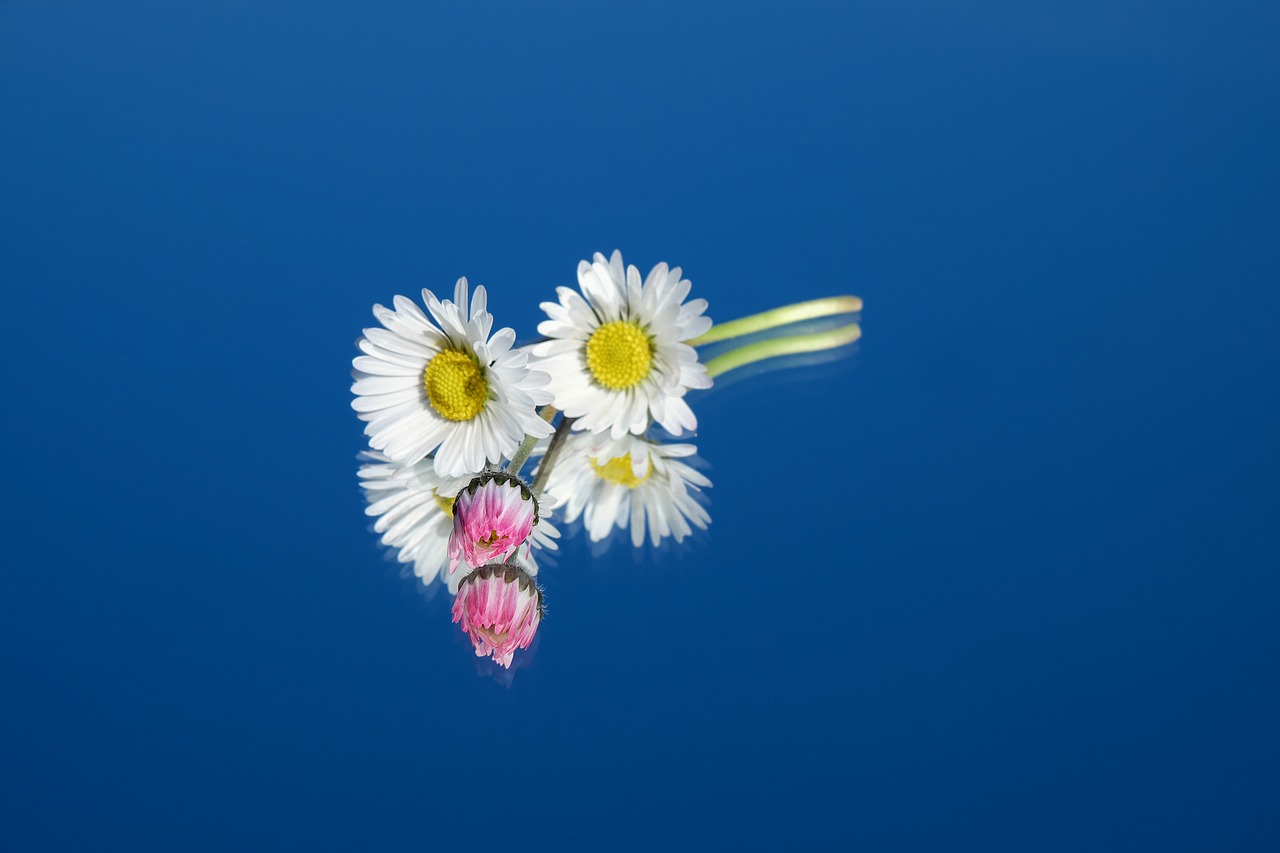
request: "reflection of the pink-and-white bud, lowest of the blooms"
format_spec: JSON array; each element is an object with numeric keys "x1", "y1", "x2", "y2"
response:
[{"x1": 453, "y1": 564, "x2": 543, "y2": 667}]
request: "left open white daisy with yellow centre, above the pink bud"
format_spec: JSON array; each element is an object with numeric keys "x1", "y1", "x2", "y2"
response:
[{"x1": 351, "y1": 278, "x2": 552, "y2": 476}]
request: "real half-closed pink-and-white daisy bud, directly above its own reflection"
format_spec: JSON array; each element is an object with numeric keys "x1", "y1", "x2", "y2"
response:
[{"x1": 449, "y1": 471, "x2": 538, "y2": 573}]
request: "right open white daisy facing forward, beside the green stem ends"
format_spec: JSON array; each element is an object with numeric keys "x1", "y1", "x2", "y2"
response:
[{"x1": 532, "y1": 251, "x2": 712, "y2": 438}]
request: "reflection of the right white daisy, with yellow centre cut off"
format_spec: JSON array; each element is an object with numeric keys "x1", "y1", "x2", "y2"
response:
[{"x1": 547, "y1": 433, "x2": 712, "y2": 548}]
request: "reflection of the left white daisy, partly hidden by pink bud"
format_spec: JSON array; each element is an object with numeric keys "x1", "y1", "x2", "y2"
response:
[{"x1": 357, "y1": 452, "x2": 559, "y2": 594}]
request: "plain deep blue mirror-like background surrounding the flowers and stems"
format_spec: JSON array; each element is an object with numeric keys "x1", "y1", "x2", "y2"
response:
[{"x1": 0, "y1": 0, "x2": 1280, "y2": 850}]
